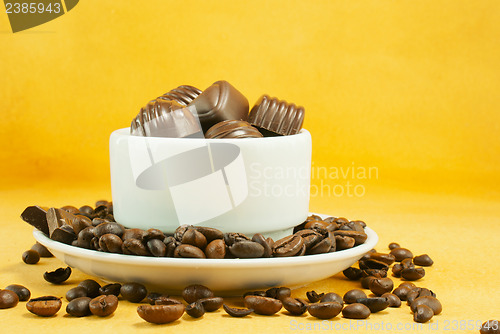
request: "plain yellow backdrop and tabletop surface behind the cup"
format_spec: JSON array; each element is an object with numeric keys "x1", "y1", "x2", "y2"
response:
[{"x1": 0, "y1": 0, "x2": 500, "y2": 333}]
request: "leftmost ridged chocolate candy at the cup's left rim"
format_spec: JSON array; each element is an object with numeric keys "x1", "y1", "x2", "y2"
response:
[{"x1": 130, "y1": 98, "x2": 201, "y2": 138}]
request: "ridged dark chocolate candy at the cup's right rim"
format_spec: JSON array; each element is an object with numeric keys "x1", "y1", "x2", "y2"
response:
[{"x1": 248, "y1": 95, "x2": 305, "y2": 135}]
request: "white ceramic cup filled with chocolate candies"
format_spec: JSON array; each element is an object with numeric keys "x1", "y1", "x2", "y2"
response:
[{"x1": 110, "y1": 128, "x2": 311, "y2": 238}]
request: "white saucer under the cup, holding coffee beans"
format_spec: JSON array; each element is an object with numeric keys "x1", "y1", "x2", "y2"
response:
[{"x1": 33, "y1": 215, "x2": 378, "y2": 295}]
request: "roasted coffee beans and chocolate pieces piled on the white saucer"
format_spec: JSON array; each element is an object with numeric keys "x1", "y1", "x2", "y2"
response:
[{"x1": 21, "y1": 201, "x2": 367, "y2": 264}]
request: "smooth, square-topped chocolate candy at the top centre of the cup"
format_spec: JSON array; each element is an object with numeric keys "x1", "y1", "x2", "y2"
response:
[{"x1": 189, "y1": 81, "x2": 249, "y2": 132}]
